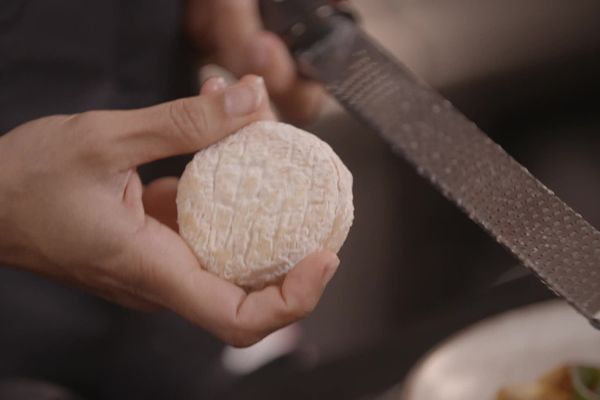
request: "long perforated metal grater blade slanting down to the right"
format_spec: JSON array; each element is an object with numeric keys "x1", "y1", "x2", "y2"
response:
[{"x1": 297, "y1": 18, "x2": 600, "y2": 328}]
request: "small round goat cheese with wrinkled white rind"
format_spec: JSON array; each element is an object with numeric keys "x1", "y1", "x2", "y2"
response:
[{"x1": 177, "y1": 121, "x2": 354, "y2": 290}]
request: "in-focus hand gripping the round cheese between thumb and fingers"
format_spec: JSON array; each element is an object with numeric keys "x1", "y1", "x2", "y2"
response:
[{"x1": 0, "y1": 77, "x2": 339, "y2": 346}]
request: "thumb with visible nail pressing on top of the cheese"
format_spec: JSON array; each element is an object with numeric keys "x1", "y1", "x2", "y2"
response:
[{"x1": 109, "y1": 76, "x2": 272, "y2": 168}]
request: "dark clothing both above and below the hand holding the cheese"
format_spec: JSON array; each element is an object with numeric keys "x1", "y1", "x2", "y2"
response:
[{"x1": 0, "y1": 0, "x2": 220, "y2": 399}]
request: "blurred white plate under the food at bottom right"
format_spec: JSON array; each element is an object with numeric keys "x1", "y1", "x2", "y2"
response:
[{"x1": 398, "y1": 301, "x2": 600, "y2": 400}]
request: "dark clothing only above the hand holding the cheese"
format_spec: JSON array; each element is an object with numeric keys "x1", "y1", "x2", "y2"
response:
[{"x1": 0, "y1": 0, "x2": 193, "y2": 133}]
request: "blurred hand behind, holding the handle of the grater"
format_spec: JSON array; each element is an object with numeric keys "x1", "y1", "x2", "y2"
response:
[{"x1": 186, "y1": 0, "x2": 324, "y2": 122}]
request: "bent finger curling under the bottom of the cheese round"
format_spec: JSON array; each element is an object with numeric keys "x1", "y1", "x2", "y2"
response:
[{"x1": 136, "y1": 222, "x2": 339, "y2": 346}]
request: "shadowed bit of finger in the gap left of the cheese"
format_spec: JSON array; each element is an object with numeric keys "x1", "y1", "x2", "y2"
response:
[{"x1": 142, "y1": 177, "x2": 179, "y2": 232}]
